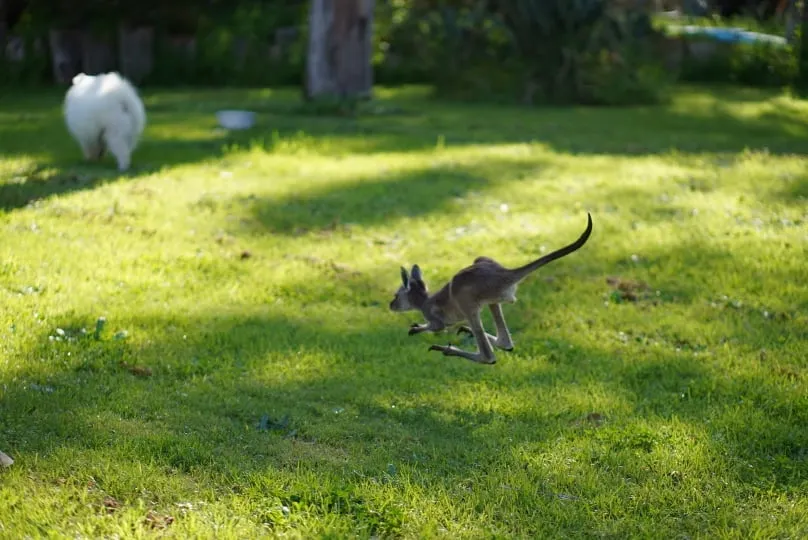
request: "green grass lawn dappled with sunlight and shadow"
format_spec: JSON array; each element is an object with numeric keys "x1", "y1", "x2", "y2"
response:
[{"x1": 0, "y1": 82, "x2": 808, "y2": 538}]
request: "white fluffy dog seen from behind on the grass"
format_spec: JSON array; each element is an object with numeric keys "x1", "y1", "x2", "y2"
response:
[{"x1": 64, "y1": 71, "x2": 146, "y2": 171}]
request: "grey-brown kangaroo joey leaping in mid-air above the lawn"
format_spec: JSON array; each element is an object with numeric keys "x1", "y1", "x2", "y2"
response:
[{"x1": 390, "y1": 213, "x2": 592, "y2": 364}]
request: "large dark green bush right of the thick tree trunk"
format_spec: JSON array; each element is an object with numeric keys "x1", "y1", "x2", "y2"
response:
[{"x1": 394, "y1": 0, "x2": 670, "y2": 105}]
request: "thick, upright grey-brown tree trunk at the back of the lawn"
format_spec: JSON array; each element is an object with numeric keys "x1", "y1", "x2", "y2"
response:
[{"x1": 304, "y1": 0, "x2": 374, "y2": 99}]
